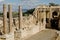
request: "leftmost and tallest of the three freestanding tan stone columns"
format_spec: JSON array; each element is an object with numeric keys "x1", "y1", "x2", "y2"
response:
[{"x1": 3, "y1": 4, "x2": 7, "y2": 34}]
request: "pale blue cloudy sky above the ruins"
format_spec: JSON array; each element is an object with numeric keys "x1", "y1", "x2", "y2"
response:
[{"x1": 0, "y1": 0, "x2": 60, "y2": 9}]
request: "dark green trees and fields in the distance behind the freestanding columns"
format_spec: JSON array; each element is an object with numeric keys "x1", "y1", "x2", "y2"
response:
[{"x1": 0, "y1": 8, "x2": 35, "y2": 17}]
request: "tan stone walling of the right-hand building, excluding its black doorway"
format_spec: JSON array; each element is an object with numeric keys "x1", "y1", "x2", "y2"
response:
[{"x1": 33, "y1": 5, "x2": 60, "y2": 29}]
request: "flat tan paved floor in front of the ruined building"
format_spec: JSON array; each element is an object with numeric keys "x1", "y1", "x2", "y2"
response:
[{"x1": 26, "y1": 30, "x2": 58, "y2": 40}]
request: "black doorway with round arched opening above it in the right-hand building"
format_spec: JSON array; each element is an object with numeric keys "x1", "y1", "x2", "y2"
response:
[{"x1": 50, "y1": 11, "x2": 59, "y2": 30}]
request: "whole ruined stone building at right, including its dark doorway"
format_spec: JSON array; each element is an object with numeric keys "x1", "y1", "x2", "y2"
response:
[{"x1": 33, "y1": 5, "x2": 60, "y2": 30}]
